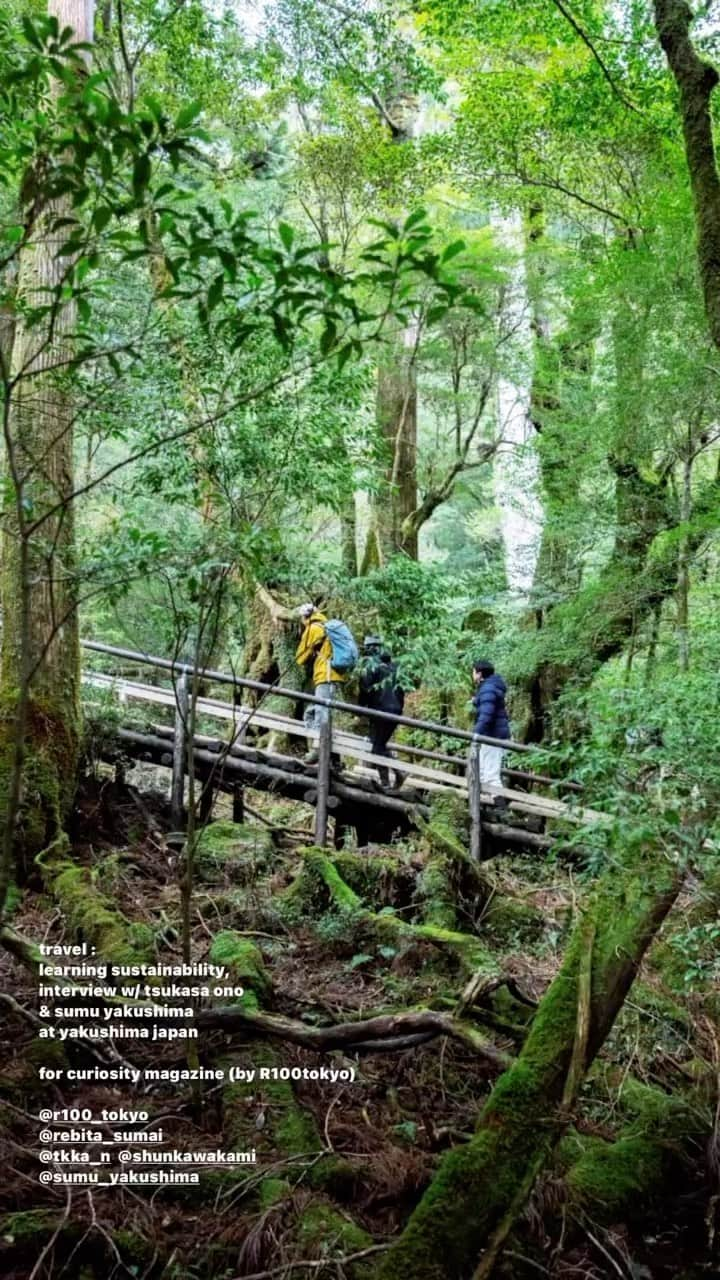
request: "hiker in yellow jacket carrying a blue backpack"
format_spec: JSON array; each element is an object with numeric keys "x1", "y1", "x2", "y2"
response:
[{"x1": 295, "y1": 604, "x2": 357, "y2": 764}]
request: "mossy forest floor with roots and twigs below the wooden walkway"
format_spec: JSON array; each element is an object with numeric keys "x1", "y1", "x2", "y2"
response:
[{"x1": 0, "y1": 762, "x2": 720, "y2": 1280}]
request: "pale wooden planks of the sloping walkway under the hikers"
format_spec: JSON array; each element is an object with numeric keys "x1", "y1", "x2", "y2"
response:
[{"x1": 82, "y1": 672, "x2": 602, "y2": 826}]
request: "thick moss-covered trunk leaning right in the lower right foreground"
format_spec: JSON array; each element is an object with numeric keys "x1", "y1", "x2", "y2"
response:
[{"x1": 377, "y1": 847, "x2": 682, "y2": 1280}]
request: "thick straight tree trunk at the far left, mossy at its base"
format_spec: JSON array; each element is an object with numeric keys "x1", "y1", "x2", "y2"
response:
[{"x1": 0, "y1": 0, "x2": 92, "y2": 911}]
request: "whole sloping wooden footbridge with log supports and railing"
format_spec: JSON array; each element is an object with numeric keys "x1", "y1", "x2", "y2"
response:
[{"x1": 82, "y1": 640, "x2": 607, "y2": 861}]
